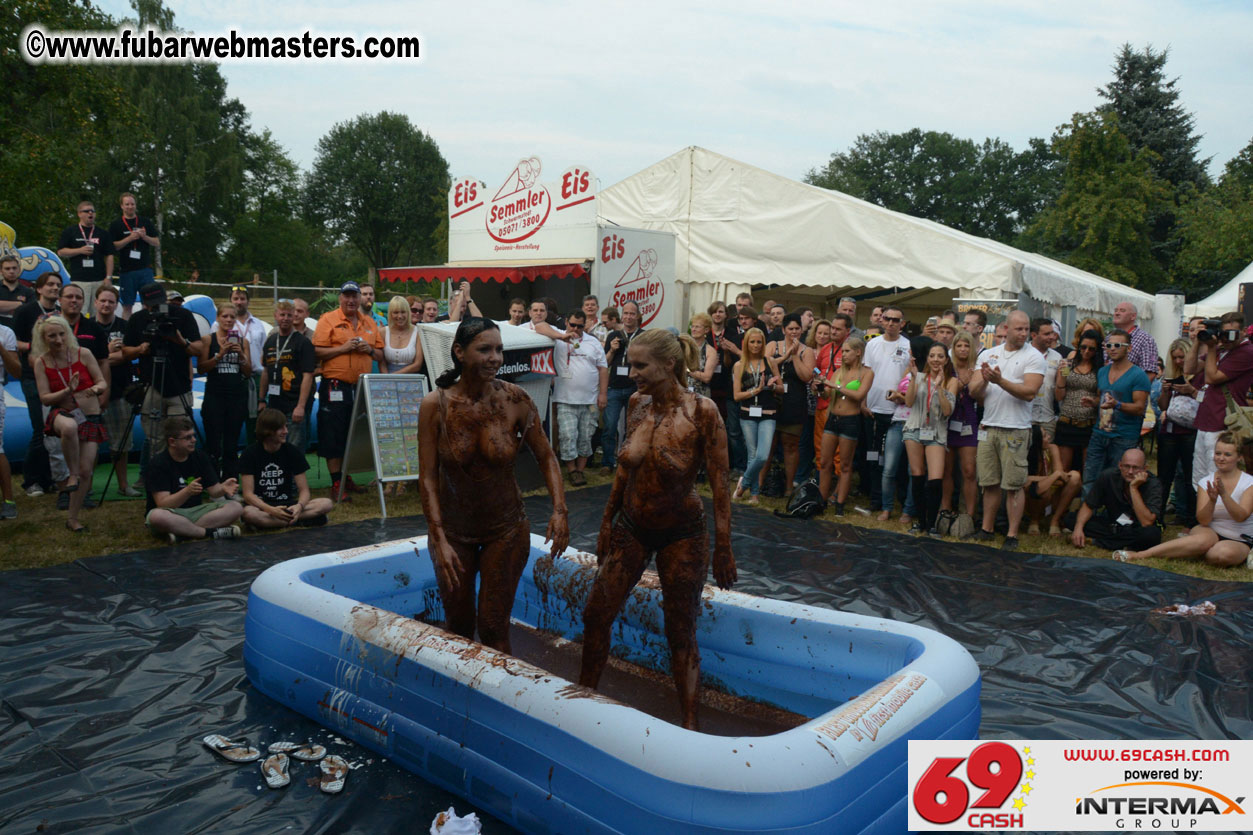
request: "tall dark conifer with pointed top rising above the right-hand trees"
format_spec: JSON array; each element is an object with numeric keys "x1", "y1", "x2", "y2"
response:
[{"x1": 1096, "y1": 44, "x2": 1209, "y2": 188}]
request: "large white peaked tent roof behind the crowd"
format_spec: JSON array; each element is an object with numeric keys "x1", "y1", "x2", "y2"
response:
[{"x1": 599, "y1": 147, "x2": 1153, "y2": 318}]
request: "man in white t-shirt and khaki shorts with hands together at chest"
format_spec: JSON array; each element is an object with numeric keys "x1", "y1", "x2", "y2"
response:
[{"x1": 970, "y1": 310, "x2": 1046, "y2": 550}]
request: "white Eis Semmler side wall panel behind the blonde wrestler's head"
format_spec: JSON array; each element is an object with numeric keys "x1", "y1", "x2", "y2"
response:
[{"x1": 591, "y1": 226, "x2": 685, "y2": 330}]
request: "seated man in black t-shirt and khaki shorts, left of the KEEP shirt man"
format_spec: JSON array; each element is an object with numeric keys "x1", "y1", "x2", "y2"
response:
[{"x1": 144, "y1": 415, "x2": 243, "y2": 544}]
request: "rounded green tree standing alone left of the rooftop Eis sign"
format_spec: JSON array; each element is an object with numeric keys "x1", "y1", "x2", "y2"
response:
[{"x1": 304, "y1": 112, "x2": 450, "y2": 270}]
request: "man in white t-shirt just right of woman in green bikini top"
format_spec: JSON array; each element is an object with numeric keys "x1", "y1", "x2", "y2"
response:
[{"x1": 862, "y1": 306, "x2": 910, "y2": 520}]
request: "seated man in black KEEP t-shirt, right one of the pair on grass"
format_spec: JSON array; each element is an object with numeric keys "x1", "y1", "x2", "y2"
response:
[{"x1": 239, "y1": 409, "x2": 335, "y2": 528}]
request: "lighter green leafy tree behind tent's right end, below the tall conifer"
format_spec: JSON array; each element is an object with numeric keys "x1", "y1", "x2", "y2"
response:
[{"x1": 1025, "y1": 113, "x2": 1170, "y2": 290}]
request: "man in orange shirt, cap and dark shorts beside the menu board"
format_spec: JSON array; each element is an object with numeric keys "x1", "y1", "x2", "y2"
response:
[{"x1": 313, "y1": 281, "x2": 383, "y2": 496}]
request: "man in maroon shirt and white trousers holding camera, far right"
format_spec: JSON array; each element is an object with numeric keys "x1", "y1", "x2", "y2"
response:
[{"x1": 1184, "y1": 311, "x2": 1253, "y2": 488}]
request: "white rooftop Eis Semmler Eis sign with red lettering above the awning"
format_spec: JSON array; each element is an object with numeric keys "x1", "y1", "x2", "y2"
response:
[{"x1": 449, "y1": 157, "x2": 596, "y2": 263}]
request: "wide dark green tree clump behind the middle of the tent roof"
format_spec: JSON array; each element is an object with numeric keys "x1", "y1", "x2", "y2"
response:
[{"x1": 804, "y1": 128, "x2": 1058, "y2": 243}]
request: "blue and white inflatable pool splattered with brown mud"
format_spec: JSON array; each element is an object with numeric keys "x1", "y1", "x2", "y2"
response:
[{"x1": 244, "y1": 537, "x2": 980, "y2": 835}]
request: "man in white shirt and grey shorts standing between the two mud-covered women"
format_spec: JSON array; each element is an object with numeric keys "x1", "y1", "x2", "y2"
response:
[{"x1": 553, "y1": 310, "x2": 609, "y2": 486}]
